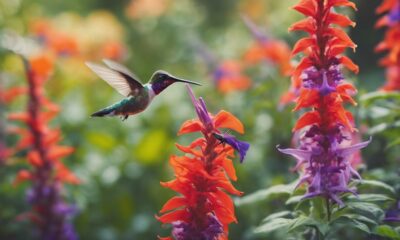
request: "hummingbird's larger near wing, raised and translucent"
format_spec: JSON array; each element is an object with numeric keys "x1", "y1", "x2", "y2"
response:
[{"x1": 86, "y1": 62, "x2": 144, "y2": 97}]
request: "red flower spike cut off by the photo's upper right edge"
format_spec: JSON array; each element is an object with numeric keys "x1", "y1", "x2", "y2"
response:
[{"x1": 375, "y1": 0, "x2": 400, "y2": 91}]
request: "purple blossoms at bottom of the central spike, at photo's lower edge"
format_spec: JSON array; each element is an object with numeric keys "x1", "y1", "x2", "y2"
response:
[{"x1": 172, "y1": 214, "x2": 224, "y2": 240}]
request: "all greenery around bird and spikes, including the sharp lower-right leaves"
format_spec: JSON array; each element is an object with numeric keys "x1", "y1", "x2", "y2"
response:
[{"x1": 0, "y1": 0, "x2": 400, "y2": 240}]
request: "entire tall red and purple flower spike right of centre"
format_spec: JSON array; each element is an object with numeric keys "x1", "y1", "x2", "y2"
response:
[{"x1": 279, "y1": 0, "x2": 369, "y2": 205}]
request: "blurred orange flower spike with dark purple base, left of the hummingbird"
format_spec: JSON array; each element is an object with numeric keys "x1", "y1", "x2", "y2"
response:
[{"x1": 8, "y1": 55, "x2": 80, "y2": 240}]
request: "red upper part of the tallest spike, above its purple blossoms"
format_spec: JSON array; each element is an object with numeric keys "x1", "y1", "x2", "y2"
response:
[{"x1": 289, "y1": 0, "x2": 358, "y2": 130}]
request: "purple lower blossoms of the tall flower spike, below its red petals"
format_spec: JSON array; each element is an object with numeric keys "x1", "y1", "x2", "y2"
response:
[{"x1": 278, "y1": 126, "x2": 371, "y2": 206}]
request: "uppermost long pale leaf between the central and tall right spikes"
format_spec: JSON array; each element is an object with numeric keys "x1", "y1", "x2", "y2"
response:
[{"x1": 235, "y1": 183, "x2": 294, "y2": 206}]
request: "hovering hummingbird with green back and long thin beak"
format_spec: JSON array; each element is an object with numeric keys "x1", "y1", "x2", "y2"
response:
[{"x1": 86, "y1": 59, "x2": 201, "y2": 121}]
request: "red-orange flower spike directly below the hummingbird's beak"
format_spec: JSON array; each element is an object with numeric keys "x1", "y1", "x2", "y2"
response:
[{"x1": 157, "y1": 86, "x2": 248, "y2": 239}]
